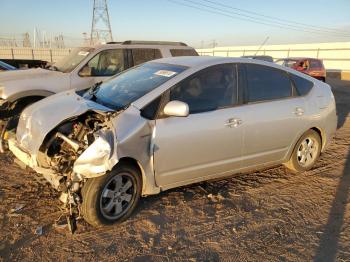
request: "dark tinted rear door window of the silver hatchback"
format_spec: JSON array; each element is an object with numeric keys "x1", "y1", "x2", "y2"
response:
[{"x1": 245, "y1": 64, "x2": 292, "y2": 103}]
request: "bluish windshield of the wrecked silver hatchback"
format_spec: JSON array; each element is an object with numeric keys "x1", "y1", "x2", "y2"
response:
[{"x1": 88, "y1": 63, "x2": 186, "y2": 110}]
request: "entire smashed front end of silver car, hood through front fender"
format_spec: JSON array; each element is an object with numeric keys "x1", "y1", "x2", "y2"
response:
[{"x1": 9, "y1": 92, "x2": 160, "y2": 231}]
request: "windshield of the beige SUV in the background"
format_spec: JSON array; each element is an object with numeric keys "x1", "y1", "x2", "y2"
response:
[{"x1": 53, "y1": 47, "x2": 94, "y2": 73}]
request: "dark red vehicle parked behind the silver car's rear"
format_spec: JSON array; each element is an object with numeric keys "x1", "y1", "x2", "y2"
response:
[{"x1": 276, "y1": 57, "x2": 326, "y2": 82}]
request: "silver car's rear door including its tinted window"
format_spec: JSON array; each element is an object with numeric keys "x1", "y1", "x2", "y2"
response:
[{"x1": 243, "y1": 64, "x2": 305, "y2": 167}]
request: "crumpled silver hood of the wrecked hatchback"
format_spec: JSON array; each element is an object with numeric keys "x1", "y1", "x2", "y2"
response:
[{"x1": 16, "y1": 90, "x2": 113, "y2": 154}]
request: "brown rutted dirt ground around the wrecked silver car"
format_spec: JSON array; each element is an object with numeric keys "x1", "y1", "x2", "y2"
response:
[{"x1": 0, "y1": 78, "x2": 350, "y2": 261}]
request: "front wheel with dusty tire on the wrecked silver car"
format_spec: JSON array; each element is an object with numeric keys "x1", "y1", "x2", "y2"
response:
[{"x1": 81, "y1": 165, "x2": 142, "y2": 227}]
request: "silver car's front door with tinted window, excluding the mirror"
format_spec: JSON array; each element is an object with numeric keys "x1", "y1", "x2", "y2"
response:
[{"x1": 154, "y1": 64, "x2": 243, "y2": 187}]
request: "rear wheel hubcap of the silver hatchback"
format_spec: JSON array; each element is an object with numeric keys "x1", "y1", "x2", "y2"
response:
[{"x1": 297, "y1": 137, "x2": 318, "y2": 167}]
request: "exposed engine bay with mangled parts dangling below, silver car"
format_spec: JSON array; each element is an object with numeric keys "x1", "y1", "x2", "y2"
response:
[{"x1": 38, "y1": 112, "x2": 113, "y2": 232}]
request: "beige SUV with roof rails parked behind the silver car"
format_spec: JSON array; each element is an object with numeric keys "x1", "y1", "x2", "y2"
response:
[{"x1": 0, "y1": 41, "x2": 198, "y2": 152}]
